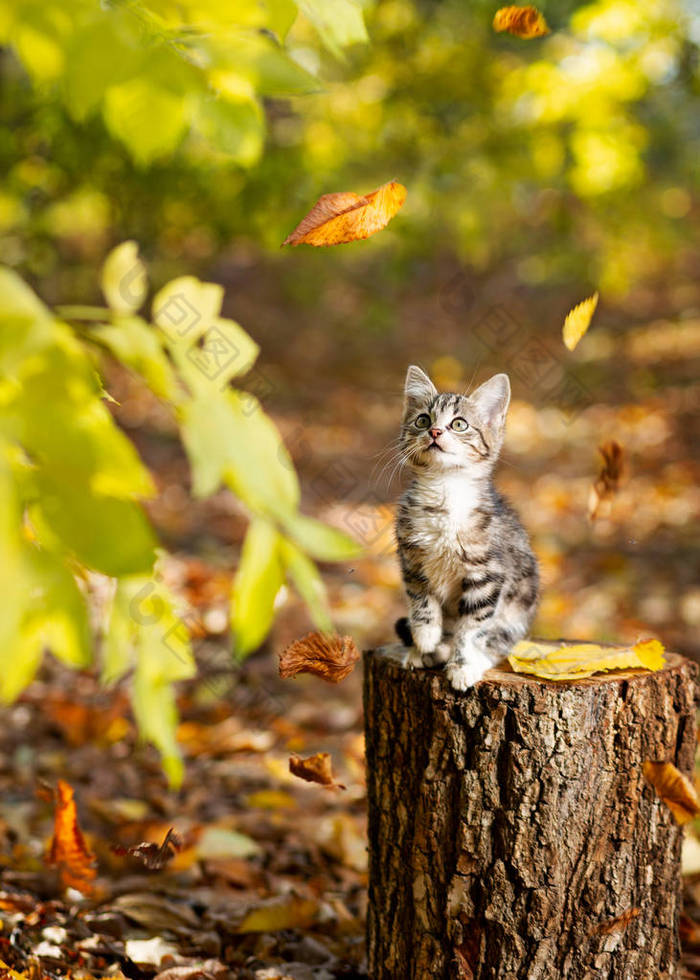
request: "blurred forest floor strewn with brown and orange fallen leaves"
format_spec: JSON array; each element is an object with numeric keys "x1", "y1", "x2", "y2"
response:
[{"x1": 0, "y1": 288, "x2": 700, "y2": 980}]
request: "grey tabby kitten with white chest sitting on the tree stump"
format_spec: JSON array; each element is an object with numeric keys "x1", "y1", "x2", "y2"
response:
[{"x1": 396, "y1": 366, "x2": 539, "y2": 691}]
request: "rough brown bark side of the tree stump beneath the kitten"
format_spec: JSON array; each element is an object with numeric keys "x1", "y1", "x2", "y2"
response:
[{"x1": 364, "y1": 644, "x2": 697, "y2": 980}]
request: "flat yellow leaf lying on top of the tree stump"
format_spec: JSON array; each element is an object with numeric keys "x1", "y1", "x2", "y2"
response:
[{"x1": 508, "y1": 640, "x2": 665, "y2": 681}]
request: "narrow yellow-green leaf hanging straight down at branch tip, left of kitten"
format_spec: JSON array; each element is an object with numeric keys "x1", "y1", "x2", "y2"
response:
[{"x1": 231, "y1": 518, "x2": 284, "y2": 659}]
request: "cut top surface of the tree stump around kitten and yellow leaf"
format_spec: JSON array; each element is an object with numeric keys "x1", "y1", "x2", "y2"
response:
[{"x1": 366, "y1": 640, "x2": 692, "y2": 696}]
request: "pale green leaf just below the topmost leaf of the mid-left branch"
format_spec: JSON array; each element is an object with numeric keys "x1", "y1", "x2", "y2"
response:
[{"x1": 90, "y1": 316, "x2": 179, "y2": 402}]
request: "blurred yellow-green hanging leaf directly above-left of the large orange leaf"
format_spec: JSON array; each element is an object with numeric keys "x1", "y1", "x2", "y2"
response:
[{"x1": 193, "y1": 97, "x2": 265, "y2": 167}]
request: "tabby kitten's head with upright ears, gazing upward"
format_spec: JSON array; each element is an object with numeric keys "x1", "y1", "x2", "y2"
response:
[{"x1": 401, "y1": 365, "x2": 510, "y2": 476}]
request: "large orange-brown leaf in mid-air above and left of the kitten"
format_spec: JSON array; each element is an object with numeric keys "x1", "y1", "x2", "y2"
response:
[{"x1": 282, "y1": 180, "x2": 406, "y2": 245}]
